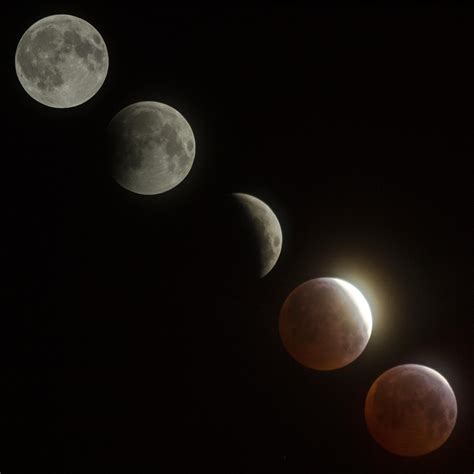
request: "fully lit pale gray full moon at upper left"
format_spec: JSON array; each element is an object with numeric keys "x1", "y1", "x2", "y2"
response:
[{"x1": 15, "y1": 15, "x2": 109, "y2": 108}]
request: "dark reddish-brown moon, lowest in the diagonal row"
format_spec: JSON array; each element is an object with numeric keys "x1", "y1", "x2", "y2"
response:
[{"x1": 365, "y1": 364, "x2": 457, "y2": 456}]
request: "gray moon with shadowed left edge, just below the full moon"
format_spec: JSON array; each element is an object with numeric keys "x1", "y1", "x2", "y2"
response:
[{"x1": 108, "y1": 102, "x2": 196, "y2": 195}]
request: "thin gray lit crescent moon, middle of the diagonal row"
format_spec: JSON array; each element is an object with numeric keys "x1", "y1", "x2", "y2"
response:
[{"x1": 232, "y1": 193, "x2": 283, "y2": 278}]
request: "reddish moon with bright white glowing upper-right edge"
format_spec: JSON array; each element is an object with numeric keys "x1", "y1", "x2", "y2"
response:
[{"x1": 279, "y1": 278, "x2": 372, "y2": 370}]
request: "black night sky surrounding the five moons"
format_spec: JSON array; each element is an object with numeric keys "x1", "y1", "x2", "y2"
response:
[{"x1": 0, "y1": 1, "x2": 474, "y2": 474}]
